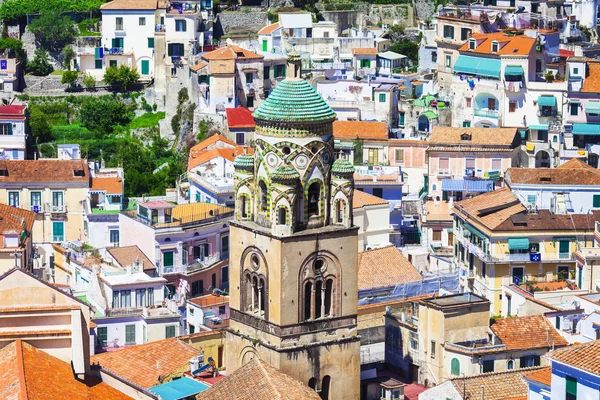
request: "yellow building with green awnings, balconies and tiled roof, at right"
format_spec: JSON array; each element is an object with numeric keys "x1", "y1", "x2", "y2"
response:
[{"x1": 453, "y1": 188, "x2": 600, "y2": 315}]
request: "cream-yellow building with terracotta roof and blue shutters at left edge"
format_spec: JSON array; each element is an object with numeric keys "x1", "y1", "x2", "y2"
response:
[{"x1": 0, "y1": 160, "x2": 90, "y2": 243}]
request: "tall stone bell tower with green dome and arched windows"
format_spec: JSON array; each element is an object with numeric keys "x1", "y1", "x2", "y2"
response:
[{"x1": 227, "y1": 52, "x2": 360, "y2": 399}]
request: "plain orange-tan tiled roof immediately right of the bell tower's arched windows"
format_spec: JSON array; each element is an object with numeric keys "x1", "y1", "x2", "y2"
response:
[{"x1": 358, "y1": 245, "x2": 423, "y2": 290}]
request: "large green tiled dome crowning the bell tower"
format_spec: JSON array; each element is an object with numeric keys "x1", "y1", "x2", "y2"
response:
[{"x1": 254, "y1": 79, "x2": 336, "y2": 122}]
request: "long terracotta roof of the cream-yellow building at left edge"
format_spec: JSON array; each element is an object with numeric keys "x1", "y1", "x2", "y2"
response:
[{"x1": 0, "y1": 160, "x2": 90, "y2": 187}]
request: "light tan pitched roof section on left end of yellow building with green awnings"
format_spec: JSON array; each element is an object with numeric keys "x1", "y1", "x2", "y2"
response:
[{"x1": 452, "y1": 188, "x2": 526, "y2": 230}]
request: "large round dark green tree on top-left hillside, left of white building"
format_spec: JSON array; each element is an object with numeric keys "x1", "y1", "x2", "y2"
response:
[{"x1": 29, "y1": 11, "x2": 77, "y2": 52}]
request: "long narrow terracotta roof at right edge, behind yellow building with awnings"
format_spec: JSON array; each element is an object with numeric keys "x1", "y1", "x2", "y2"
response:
[{"x1": 506, "y1": 167, "x2": 600, "y2": 186}]
